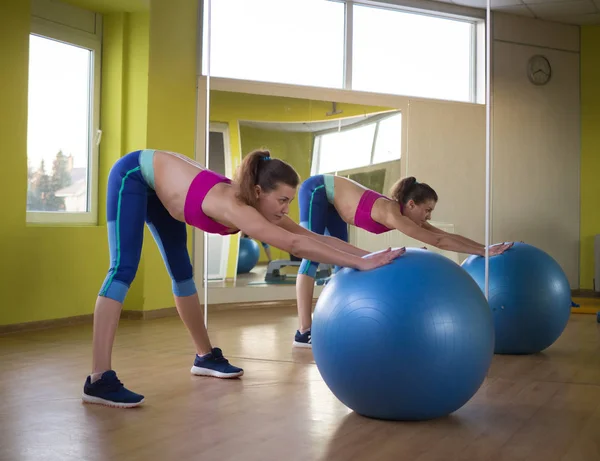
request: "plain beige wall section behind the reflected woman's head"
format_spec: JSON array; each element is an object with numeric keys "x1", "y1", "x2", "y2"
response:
[{"x1": 403, "y1": 100, "x2": 485, "y2": 262}]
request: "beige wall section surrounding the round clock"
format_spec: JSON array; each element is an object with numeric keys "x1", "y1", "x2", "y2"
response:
[{"x1": 492, "y1": 14, "x2": 580, "y2": 288}]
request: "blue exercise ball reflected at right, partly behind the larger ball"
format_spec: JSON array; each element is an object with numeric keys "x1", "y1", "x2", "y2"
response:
[{"x1": 462, "y1": 243, "x2": 571, "y2": 354}]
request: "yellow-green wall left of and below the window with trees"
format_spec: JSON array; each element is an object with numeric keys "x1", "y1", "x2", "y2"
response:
[{"x1": 0, "y1": 0, "x2": 113, "y2": 325}]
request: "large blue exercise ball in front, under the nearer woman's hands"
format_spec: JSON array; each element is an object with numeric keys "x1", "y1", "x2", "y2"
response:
[{"x1": 312, "y1": 248, "x2": 494, "y2": 420}]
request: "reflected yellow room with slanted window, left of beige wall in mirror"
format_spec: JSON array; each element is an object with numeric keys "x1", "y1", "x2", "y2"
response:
[{"x1": 203, "y1": 90, "x2": 402, "y2": 302}]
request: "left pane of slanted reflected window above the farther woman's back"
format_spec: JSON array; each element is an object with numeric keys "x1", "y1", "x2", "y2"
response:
[{"x1": 318, "y1": 123, "x2": 375, "y2": 173}]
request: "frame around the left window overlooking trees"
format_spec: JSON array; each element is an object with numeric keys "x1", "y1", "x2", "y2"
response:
[{"x1": 26, "y1": 14, "x2": 102, "y2": 225}]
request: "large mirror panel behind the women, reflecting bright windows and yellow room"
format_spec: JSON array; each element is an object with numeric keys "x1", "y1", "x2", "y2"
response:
[{"x1": 199, "y1": 1, "x2": 486, "y2": 352}]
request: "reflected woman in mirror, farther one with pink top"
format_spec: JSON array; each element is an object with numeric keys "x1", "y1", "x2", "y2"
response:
[{"x1": 293, "y1": 174, "x2": 512, "y2": 347}]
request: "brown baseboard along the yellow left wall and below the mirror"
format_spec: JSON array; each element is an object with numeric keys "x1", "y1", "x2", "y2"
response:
[{"x1": 0, "y1": 300, "x2": 316, "y2": 335}]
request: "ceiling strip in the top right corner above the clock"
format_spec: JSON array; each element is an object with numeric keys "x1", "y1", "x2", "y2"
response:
[{"x1": 437, "y1": 0, "x2": 600, "y2": 25}]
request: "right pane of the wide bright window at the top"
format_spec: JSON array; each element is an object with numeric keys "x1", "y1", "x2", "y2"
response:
[{"x1": 352, "y1": 5, "x2": 474, "y2": 101}]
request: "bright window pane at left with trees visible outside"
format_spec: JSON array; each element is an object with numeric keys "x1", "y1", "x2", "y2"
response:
[{"x1": 27, "y1": 35, "x2": 92, "y2": 212}]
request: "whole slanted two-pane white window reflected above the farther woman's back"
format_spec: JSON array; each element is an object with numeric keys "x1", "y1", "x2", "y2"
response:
[{"x1": 311, "y1": 112, "x2": 402, "y2": 175}]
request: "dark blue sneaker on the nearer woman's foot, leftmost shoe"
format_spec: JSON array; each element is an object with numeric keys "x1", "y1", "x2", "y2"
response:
[{"x1": 82, "y1": 370, "x2": 144, "y2": 408}]
